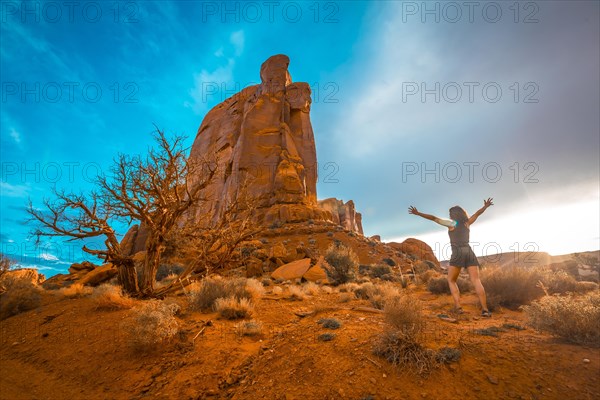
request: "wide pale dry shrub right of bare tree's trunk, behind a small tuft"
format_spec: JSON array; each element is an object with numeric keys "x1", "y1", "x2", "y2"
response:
[{"x1": 189, "y1": 277, "x2": 252, "y2": 311}]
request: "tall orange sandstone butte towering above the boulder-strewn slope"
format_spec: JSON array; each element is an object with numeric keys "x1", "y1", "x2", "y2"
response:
[{"x1": 190, "y1": 54, "x2": 362, "y2": 233}]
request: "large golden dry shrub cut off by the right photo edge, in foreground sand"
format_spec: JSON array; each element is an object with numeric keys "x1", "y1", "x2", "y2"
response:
[{"x1": 523, "y1": 292, "x2": 600, "y2": 346}]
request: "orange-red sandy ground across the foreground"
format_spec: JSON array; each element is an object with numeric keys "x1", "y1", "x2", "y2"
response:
[{"x1": 0, "y1": 287, "x2": 600, "y2": 400}]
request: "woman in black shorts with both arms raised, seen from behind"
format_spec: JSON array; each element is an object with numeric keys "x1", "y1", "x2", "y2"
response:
[{"x1": 408, "y1": 198, "x2": 494, "y2": 318}]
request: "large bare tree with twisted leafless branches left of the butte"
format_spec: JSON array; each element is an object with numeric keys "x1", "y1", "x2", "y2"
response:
[{"x1": 27, "y1": 128, "x2": 216, "y2": 296}]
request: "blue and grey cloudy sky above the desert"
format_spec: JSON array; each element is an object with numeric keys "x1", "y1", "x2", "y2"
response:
[{"x1": 0, "y1": 1, "x2": 600, "y2": 272}]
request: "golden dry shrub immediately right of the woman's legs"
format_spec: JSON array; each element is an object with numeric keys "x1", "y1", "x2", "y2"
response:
[{"x1": 481, "y1": 267, "x2": 544, "y2": 308}]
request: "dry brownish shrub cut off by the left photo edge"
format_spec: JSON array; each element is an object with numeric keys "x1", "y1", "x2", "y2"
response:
[{"x1": 0, "y1": 279, "x2": 42, "y2": 321}]
